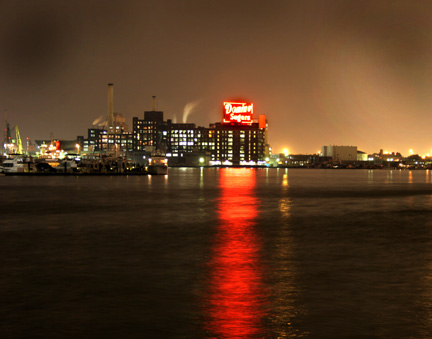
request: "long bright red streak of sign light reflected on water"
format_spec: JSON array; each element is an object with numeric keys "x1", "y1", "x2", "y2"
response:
[{"x1": 206, "y1": 169, "x2": 264, "y2": 338}]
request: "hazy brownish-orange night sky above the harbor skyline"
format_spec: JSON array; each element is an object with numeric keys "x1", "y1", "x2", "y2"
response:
[{"x1": 0, "y1": 0, "x2": 432, "y2": 155}]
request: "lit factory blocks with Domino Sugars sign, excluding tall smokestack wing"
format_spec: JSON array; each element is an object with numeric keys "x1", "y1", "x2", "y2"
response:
[{"x1": 133, "y1": 102, "x2": 267, "y2": 165}]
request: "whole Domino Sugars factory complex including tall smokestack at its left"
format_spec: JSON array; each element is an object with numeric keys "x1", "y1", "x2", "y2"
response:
[{"x1": 79, "y1": 84, "x2": 269, "y2": 166}]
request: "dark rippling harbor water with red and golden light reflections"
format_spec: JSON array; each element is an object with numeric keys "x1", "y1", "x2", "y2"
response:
[{"x1": 0, "y1": 169, "x2": 432, "y2": 338}]
